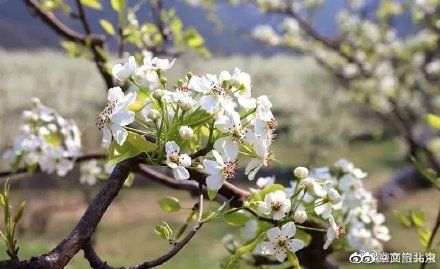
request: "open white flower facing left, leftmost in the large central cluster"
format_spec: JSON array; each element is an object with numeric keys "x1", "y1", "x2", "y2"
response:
[{"x1": 96, "y1": 87, "x2": 136, "y2": 146}]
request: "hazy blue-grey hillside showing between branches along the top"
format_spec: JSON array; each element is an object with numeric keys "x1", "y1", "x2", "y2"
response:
[{"x1": 0, "y1": 0, "x2": 344, "y2": 55}]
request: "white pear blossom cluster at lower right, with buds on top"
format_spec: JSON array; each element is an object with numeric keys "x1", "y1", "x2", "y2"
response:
[{"x1": 224, "y1": 159, "x2": 391, "y2": 262}]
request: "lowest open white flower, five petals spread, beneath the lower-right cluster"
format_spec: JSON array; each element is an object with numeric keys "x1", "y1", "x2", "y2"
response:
[{"x1": 261, "y1": 222, "x2": 304, "y2": 262}]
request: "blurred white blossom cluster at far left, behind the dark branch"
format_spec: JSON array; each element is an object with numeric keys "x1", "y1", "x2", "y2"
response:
[{"x1": 3, "y1": 98, "x2": 81, "y2": 176}]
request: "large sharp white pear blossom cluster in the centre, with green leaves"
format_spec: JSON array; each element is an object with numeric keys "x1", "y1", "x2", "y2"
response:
[{"x1": 105, "y1": 55, "x2": 277, "y2": 191}]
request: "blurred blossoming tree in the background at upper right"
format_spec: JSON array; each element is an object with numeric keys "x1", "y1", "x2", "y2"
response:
[{"x1": 248, "y1": 0, "x2": 440, "y2": 182}]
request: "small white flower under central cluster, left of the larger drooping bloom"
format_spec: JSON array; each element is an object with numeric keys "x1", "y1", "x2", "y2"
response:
[{"x1": 165, "y1": 141, "x2": 191, "y2": 180}]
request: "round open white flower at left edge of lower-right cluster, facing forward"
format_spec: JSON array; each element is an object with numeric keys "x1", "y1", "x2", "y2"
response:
[{"x1": 258, "y1": 190, "x2": 292, "y2": 220}]
